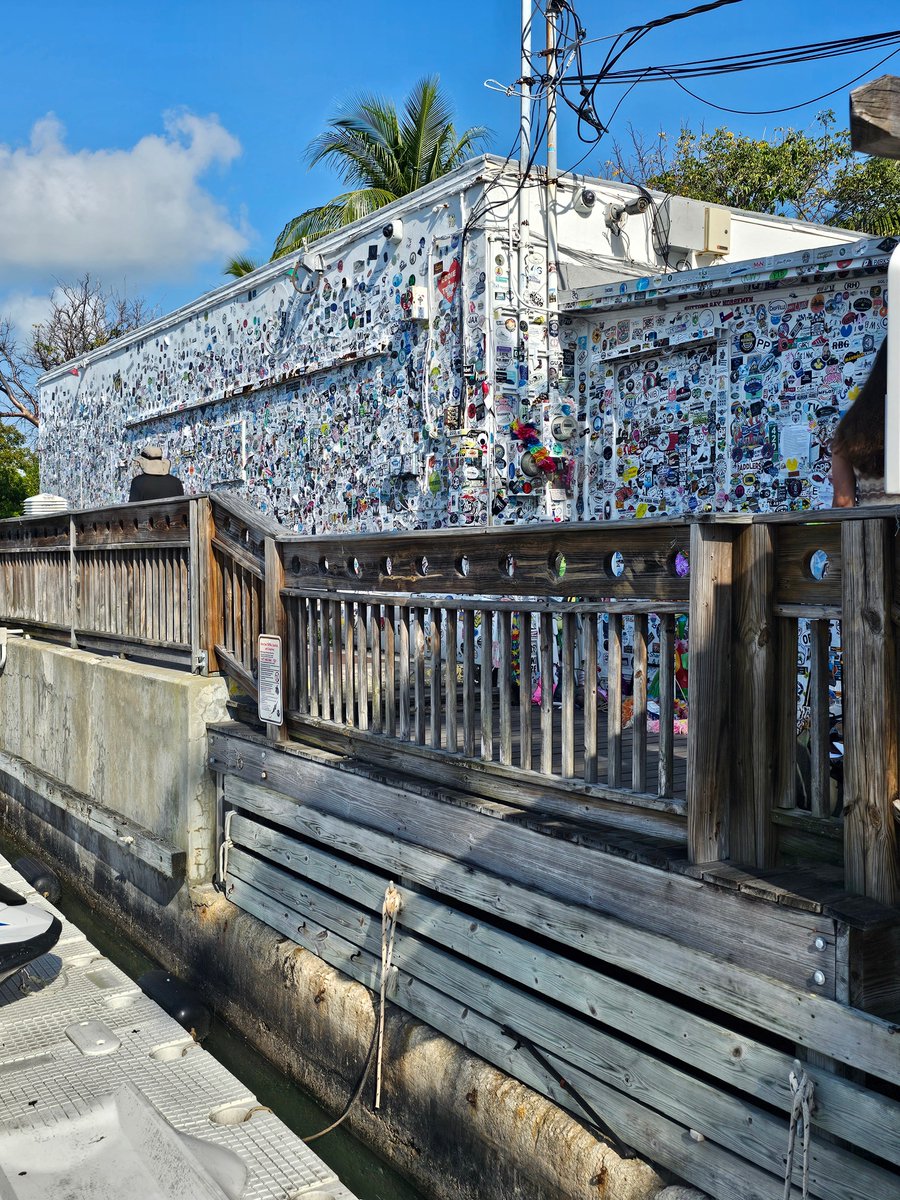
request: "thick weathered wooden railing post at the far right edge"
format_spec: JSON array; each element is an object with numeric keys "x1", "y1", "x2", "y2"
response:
[{"x1": 842, "y1": 518, "x2": 900, "y2": 905}]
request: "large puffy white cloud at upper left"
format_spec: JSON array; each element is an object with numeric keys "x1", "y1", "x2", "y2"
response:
[{"x1": 0, "y1": 113, "x2": 247, "y2": 280}]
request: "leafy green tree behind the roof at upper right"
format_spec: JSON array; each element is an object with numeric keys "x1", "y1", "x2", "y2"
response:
[{"x1": 611, "y1": 110, "x2": 900, "y2": 235}]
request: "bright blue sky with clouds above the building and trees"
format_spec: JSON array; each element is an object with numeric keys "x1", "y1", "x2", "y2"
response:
[{"x1": 0, "y1": 0, "x2": 900, "y2": 328}]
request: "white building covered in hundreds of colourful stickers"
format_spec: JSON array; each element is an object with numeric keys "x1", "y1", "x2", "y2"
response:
[{"x1": 40, "y1": 157, "x2": 893, "y2": 533}]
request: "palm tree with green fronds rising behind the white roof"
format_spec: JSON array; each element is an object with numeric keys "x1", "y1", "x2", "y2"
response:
[{"x1": 226, "y1": 76, "x2": 488, "y2": 277}]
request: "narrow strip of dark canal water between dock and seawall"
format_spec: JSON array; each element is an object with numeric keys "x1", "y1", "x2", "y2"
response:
[{"x1": 0, "y1": 838, "x2": 426, "y2": 1200}]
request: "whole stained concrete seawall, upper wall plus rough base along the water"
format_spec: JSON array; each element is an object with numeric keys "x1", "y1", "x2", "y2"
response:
[{"x1": 0, "y1": 641, "x2": 697, "y2": 1200}]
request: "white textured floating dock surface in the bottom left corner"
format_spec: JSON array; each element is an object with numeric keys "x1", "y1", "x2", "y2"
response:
[{"x1": 0, "y1": 858, "x2": 354, "y2": 1200}]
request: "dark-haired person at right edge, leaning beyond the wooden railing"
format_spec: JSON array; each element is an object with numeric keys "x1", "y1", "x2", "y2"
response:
[{"x1": 832, "y1": 338, "x2": 900, "y2": 509}]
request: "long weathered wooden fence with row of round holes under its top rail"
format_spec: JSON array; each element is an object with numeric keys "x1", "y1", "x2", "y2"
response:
[{"x1": 0, "y1": 494, "x2": 900, "y2": 904}]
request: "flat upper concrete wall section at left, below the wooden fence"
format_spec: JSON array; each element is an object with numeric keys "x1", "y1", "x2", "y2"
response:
[{"x1": 0, "y1": 638, "x2": 227, "y2": 883}]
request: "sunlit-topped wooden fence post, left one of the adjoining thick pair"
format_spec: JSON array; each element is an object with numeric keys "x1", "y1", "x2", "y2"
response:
[{"x1": 688, "y1": 523, "x2": 734, "y2": 863}]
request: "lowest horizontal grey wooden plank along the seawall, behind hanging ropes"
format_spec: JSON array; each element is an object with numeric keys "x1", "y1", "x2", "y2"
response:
[{"x1": 229, "y1": 850, "x2": 894, "y2": 1200}]
